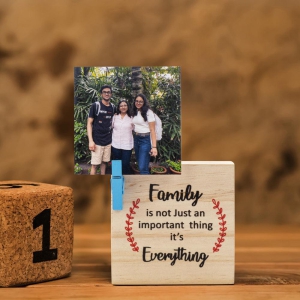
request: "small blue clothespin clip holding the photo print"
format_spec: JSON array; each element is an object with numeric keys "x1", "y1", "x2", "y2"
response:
[{"x1": 111, "y1": 160, "x2": 124, "y2": 210}]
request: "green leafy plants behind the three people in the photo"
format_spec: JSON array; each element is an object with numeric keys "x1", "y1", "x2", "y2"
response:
[{"x1": 74, "y1": 67, "x2": 181, "y2": 162}]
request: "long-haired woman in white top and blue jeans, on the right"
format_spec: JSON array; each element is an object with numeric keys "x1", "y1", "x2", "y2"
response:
[{"x1": 132, "y1": 94, "x2": 157, "y2": 174}]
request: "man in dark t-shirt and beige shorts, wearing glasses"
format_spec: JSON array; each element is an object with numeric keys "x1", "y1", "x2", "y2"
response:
[{"x1": 87, "y1": 85, "x2": 115, "y2": 175}]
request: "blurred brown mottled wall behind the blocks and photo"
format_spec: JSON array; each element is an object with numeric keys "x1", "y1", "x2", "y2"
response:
[{"x1": 0, "y1": 0, "x2": 300, "y2": 224}]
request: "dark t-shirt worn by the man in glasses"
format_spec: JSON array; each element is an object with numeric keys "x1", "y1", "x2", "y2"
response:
[{"x1": 89, "y1": 101, "x2": 114, "y2": 146}]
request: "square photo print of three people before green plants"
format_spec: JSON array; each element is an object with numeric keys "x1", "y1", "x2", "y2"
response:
[{"x1": 74, "y1": 66, "x2": 181, "y2": 175}]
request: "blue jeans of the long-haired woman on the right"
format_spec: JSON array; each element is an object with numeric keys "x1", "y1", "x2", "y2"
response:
[{"x1": 134, "y1": 135, "x2": 151, "y2": 175}]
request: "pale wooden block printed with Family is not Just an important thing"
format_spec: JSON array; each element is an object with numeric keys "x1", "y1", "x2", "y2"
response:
[{"x1": 111, "y1": 161, "x2": 235, "y2": 285}]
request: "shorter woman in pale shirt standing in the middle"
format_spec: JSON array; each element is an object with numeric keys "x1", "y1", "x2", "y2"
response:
[{"x1": 111, "y1": 100, "x2": 133, "y2": 174}]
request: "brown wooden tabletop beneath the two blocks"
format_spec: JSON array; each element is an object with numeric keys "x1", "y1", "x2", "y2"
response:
[{"x1": 0, "y1": 224, "x2": 300, "y2": 300}]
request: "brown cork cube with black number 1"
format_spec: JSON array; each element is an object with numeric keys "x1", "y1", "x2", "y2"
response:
[{"x1": 0, "y1": 181, "x2": 74, "y2": 287}]
